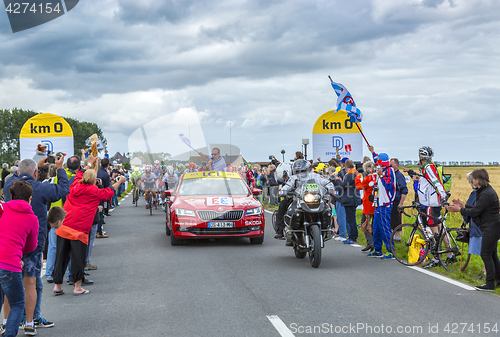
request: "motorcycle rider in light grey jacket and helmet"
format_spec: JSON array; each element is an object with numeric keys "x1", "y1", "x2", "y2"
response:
[{"x1": 278, "y1": 159, "x2": 335, "y2": 246}]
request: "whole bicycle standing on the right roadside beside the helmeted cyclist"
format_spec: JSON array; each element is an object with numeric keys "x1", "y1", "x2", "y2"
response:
[{"x1": 390, "y1": 202, "x2": 470, "y2": 271}]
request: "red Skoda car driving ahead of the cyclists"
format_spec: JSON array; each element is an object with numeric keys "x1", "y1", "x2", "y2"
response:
[{"x1": 166, "y1": 171, "x2": 265, "y2": 246}]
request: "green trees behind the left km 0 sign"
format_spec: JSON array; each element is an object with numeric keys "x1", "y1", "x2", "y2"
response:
[{"x1": 0, "y1": 108, "x2": 107, "y2": 164}]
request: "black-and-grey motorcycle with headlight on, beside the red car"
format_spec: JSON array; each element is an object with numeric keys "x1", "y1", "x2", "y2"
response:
[{"x1": 283, "y1": 179, "x2": 333, "y2": 268}]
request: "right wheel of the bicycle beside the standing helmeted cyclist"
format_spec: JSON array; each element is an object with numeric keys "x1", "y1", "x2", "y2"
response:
[{"x1": 438, "y1": 228, "x2": 470, "y2": 271}]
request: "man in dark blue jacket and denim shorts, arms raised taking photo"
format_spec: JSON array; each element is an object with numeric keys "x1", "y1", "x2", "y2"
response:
[{"x1": 5, "y1": 156, "x2": 69, "y2": 336}]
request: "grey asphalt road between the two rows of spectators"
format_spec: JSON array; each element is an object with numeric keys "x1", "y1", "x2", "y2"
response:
[{"x1": 32, "y1": 192, "x2": 500, "y2": 337}]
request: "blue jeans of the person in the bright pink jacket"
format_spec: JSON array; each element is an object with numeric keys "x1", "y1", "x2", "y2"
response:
[{"x1": 0, "y1": 269, "x2": 24, "y2": 337}]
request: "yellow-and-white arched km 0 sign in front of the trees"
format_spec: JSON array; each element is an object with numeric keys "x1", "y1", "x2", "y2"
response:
[{"x1": 19, "y1": 113, "x2": 74, "y2": 160}]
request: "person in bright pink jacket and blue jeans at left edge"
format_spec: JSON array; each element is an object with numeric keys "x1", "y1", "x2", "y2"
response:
[{"x1": 0, "y1": 181, "x2": 38, "y2": 337}]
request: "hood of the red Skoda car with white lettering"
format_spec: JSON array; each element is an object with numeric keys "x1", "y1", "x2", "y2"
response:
[{"x1": 174, "y1": 195, "x2": 261, "y2": 212}]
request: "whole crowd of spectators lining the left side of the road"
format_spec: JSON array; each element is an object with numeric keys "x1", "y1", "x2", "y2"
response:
[{"x1": 0, "y1": 151, "x2": 127, "y2": 336}]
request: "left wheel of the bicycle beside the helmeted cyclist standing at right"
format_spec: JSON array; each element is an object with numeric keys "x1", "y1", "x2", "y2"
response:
[{"x1": 390, "y1": 223, "x2": 429, "y2": 266}]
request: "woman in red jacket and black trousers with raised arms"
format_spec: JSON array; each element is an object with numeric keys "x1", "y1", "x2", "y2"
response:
[{"x1": 53, "y1": 156, "x2": 126, "y2": 295}]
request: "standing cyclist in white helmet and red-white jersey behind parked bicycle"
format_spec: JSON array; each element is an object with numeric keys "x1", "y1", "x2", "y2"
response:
[{"x1": 404, "y1": 146, "x2": 457, "y2": 268}]
